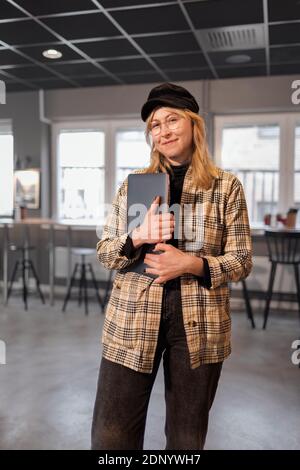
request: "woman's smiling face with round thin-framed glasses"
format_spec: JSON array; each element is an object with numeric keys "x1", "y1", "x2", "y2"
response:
[{"x1": 150, "y1": 108, "x2": 193, "y2": 165}]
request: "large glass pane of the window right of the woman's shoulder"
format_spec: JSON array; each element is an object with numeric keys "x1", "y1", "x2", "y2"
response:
[{"x1": 222, "y1": 125, "x2": 280, "y2": 222}]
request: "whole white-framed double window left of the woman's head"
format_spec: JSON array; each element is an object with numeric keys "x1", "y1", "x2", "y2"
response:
[{"x1": 52, "y1": 119, "x2": 150, "y2": 225}]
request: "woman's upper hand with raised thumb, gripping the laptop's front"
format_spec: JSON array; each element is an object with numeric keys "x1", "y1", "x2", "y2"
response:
[{"x1": 132, "y1": 196, "x2": 175, "y2": 248}]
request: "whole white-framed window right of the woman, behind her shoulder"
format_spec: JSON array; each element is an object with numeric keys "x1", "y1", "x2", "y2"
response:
[{"x1": 215, "y1": 114, "x2": 300, "y2": 225}]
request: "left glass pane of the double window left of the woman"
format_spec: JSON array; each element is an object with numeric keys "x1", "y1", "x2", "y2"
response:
[{"x1": 58, "y1": 131, "x2": 105, "y2": 223}]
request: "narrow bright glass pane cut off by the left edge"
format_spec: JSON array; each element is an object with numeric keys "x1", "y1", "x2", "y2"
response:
[{"x1": 0, "y1": 133, "x2": 14, "y2": 217}]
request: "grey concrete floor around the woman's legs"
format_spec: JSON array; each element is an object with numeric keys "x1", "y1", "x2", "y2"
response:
[{"x1": 0, "y1": 297, "x2": 300, "y2": 449}]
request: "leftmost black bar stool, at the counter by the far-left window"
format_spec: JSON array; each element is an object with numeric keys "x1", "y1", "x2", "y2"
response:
[{"x1": 6, "y1": 226, "x2": 45, "y2": 310}]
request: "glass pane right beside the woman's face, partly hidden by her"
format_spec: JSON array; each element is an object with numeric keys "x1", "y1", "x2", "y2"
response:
[{"x1": 116, "y1": 129, "x2": 150, "y2": 188}]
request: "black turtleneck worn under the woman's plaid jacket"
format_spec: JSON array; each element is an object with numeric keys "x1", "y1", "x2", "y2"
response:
[{"x1": 122, "y1": 163, "x2": 211, "y2": 289}]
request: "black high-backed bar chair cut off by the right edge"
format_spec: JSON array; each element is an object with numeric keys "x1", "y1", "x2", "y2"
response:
[{"x1": 263, "y1": 229, "x2": 300, "y2": 329}]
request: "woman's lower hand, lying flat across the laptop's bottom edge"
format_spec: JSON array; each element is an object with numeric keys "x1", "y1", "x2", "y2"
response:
[{"x1": 144, "y1": 243, "x2": 203, "y2": 283}]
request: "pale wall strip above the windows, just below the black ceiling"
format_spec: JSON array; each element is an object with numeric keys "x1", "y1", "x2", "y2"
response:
[{"x1": 45, "y1": 75, "x2": 300, "y2": 120}]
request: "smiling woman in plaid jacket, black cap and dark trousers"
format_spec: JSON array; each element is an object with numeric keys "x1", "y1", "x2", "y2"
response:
[{"x1": 92, "y1": 83, "x2": 252, "y2": 450}]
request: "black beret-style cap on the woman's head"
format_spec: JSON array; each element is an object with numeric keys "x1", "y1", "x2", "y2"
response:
[{"x1": 141, "y1": 83, "x2": 199, "y2": 121}]
